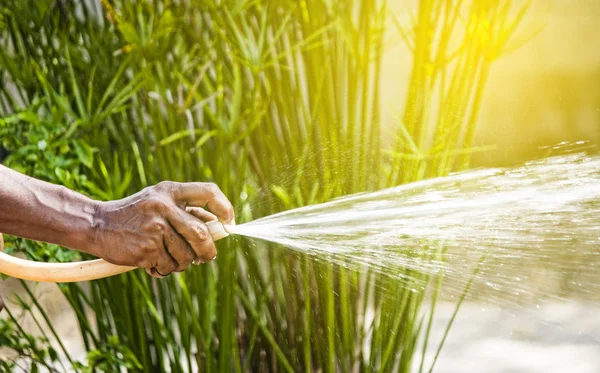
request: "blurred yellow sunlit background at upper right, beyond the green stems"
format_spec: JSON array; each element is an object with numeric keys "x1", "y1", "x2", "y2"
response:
[{"x1": 382, "y1": 0, "x2": 600, "y2": 167}]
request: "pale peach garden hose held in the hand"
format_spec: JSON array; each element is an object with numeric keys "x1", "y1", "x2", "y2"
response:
[{"x1": 0, "y1": 220, "x2": 229, "y2": 282}]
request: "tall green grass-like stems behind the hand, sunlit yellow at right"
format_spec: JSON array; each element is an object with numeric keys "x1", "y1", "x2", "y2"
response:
[{"x1": 0, "y1": 0, "x2": 526, "y2": 372}]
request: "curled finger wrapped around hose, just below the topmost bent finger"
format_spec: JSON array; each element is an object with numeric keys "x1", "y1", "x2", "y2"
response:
[{"x1": 167, "y1": 208, "x2": 217, "y2": 263}]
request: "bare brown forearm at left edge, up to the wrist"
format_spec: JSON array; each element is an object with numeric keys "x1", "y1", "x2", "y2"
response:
[{"x1": 0, "y1": 165, "x2": 98, "y2": 255}]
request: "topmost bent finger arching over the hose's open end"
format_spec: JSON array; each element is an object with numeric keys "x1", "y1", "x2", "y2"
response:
[{"x1": 172, "y1": 183, "x2": 235, "y2": 224}]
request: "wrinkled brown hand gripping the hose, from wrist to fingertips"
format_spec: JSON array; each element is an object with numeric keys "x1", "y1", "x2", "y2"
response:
[{"x1": 88, "y1": 181, "x2": 235, "y2": 277}]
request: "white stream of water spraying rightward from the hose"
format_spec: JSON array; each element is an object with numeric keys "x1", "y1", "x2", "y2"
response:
[{"x1": 231, "y1": 153, "x2": 600, "y2": 303}]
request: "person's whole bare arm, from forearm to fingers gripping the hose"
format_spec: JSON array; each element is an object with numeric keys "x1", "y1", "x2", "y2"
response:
[{"x1": 0, "y1": 165, "x2": 234, "y2": 277}]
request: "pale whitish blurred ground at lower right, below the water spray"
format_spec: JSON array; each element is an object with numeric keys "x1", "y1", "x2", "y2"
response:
[{"x1": 415, "y1": 300, "x2": 600, "y2": 373}]
